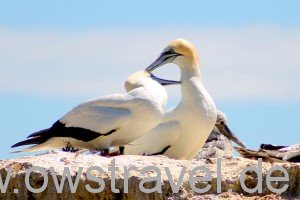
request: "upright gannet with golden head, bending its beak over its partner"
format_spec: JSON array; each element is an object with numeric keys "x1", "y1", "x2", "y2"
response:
[{"x1": 124, "y1": 39, "x2": 217, "y2": 159}]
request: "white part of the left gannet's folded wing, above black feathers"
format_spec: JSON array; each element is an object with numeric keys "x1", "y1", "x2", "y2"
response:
[{"x1": 59, "y1": 94, "x2": 134, "y2": 134}]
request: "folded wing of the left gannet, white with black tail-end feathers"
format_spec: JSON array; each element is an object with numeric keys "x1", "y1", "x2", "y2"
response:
[{"x1": 12, "y1": 95, "x2": 133, "y2": 150}]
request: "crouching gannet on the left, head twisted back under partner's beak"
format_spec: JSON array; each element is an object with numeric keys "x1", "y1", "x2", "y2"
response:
[{"x1": 12, "y1": 71, "x2": 178, "y2": 151}]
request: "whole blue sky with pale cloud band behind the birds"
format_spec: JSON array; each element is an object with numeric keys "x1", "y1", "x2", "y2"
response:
[{"x1": 0, "y1": 0, "x2": 300, "y2": 158}]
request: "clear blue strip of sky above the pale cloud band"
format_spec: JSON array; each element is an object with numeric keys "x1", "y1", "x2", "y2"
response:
[{"x1": 0, "y1": 0, "x2": 300, "y2": 28}]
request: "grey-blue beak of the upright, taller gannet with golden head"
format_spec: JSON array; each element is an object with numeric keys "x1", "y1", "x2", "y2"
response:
[{"x1": 146, "y1": 50, "x2": 182, "y2": 72}]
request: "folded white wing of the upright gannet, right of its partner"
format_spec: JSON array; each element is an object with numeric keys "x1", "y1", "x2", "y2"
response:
[{"x1": 124, "y1": 121, "x2": 180, "y2": 155}]
